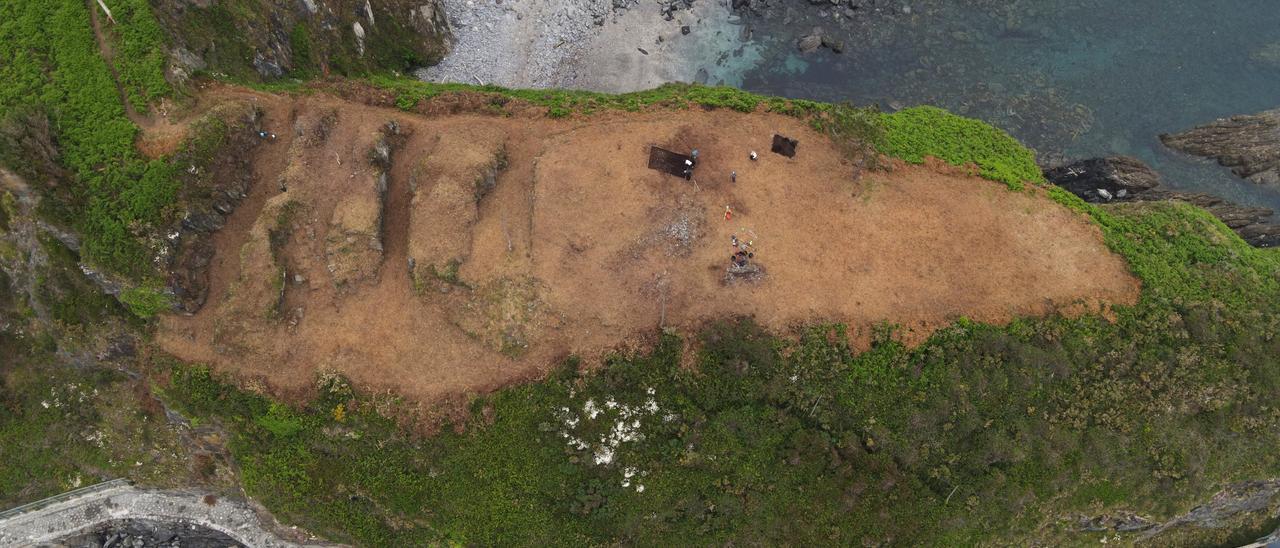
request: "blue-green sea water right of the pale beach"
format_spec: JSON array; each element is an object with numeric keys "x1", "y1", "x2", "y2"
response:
[{"x1": 744, "y1": 0, "x2": 1280, "y2": 210}]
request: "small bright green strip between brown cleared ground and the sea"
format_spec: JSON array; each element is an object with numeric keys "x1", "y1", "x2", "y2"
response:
[{"x1": 879, "y1": 106, "x2": 1044, "y2": 189}]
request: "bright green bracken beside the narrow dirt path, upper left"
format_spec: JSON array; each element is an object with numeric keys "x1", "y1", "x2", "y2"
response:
[{"x1": 0, "y1": 0, "x2": 177, "y2": 278}]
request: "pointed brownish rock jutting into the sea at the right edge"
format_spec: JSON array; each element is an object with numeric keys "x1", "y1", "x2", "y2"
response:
[{"x1": 1160, "y1": 109, "x2": 1280, "y2": 184}]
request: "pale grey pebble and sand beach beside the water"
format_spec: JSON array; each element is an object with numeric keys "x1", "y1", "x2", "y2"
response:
[{"x1": 413, "y1": 0, "x2": 763, "y2": 92}]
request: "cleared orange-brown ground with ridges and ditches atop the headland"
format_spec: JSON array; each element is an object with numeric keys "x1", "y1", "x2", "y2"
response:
[{"x1": 157, "y1": 88, "x2": 1138, "y2": 402}]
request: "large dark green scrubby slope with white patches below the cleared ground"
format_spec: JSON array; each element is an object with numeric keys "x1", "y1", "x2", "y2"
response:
[{"x1": 166, "y1": 198, "x2": 1280, "y2": 545}]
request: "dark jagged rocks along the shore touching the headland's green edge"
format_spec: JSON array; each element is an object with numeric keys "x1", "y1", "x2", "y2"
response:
[{"x1": 1044, "y1": 156, "x2": 1280, "y2": 247}]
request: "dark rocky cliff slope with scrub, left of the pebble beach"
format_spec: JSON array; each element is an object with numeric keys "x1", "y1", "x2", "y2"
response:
[{"x1": 152, "y1": 0, "x2": 451, "y2": 81}]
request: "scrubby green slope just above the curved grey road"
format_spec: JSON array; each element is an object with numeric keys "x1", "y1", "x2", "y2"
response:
[{"x1": 0, "y1": 280, "x2": 186, "y2": 508}]
